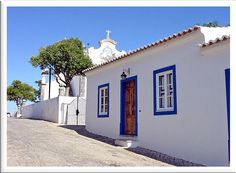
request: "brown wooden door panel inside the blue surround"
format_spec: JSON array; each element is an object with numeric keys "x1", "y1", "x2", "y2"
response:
[{"x1": 124, "y1": 80, "x2": 136, "y2": 135}]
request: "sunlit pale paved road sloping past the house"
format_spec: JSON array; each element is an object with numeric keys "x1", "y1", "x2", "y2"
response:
[{"x1": 7, "y1": 118, "x2": 171, "y2": 166}]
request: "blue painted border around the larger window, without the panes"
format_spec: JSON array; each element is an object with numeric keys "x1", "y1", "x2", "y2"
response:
[{"x1": 153, "y1": 65, "x2": 177, "y2": 115}]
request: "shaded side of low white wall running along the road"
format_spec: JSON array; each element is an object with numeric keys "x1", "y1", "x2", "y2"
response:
[{"x1": 22, "y1": 97, "x2": 59, "y2": 123}]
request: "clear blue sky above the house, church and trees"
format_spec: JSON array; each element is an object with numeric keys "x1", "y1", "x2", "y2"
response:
[{"x1": 7, "y1": 7, "x2": 230, "y2": 111}]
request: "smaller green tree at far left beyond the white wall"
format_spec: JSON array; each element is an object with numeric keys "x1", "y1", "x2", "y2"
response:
[{"x1": 7, "y1": 80, "x2": 35, "y2": 113}]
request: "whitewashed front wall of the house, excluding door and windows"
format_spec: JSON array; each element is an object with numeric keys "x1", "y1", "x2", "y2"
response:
[{"x1": 86, "y1": 28, "x2": 230, "y2": 166}]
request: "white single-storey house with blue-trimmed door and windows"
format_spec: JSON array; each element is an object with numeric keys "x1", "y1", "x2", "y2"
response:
[{"x1": 84, "y1": 26, "x2": 230, "y2": 166}]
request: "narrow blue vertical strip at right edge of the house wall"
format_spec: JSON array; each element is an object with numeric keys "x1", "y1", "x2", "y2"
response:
[{"x1": 225, "y1": 69, "x2": 230, "y2": 161}]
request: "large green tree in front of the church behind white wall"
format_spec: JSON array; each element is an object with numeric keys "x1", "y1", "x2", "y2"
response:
[{"x1": 30, "y1": 38, "x2": 92, "y2": 96}]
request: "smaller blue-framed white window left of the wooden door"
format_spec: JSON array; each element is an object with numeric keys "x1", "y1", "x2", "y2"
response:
[{"x1": 97, "y1": 83, "x2": 109, "y2": 118}]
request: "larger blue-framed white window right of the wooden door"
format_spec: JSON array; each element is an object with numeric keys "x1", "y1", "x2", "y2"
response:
[{"x1": 153, "y1": 65, "x2": 177, "y2": 115}]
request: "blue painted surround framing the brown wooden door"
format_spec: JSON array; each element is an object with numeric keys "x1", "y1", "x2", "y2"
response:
[{"x1": 120, "y1": 76, "x2": 138, "y2": 136}]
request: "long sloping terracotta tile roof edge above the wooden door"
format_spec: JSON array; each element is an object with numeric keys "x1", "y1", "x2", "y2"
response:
[{"x1": 83, "y1": 26, "x2": 200, "y2": 73}]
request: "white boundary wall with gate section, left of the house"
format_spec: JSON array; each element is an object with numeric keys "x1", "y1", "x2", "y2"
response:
[{"x1": 22, "y1": 96, "x2": 86, "y2": 125}]
